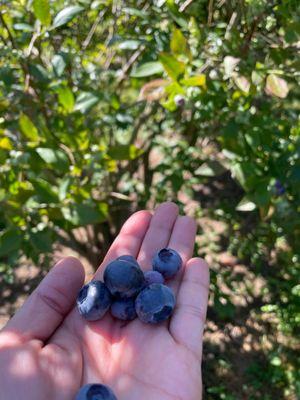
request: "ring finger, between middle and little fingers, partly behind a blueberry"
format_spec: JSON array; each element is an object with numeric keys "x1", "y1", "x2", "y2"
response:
[{"x1": 168, "y1": 216, "x2": 197, "y2": 295}]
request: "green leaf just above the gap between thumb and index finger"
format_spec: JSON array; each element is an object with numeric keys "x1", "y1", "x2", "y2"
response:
[{"x1": 62, "y1": 202, "x2": 108, "y2": 226}]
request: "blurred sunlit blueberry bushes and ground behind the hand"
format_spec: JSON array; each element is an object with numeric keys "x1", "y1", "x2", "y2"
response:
[{"x1": 0, "y1": 0, "x2": 300, "y2": 400}]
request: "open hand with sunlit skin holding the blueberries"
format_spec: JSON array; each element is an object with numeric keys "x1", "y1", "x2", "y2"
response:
[{"x1": 0, "y1": 203, "x2": 209, "y2": 400}]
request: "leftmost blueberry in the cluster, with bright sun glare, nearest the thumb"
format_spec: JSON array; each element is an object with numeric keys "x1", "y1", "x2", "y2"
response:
[{"x1": 77, "y1": 280, "x2": 112, "y2": 321}]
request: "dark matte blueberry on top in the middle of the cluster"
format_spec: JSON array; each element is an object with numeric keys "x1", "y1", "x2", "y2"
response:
[{"x1": 104, "y1": 260, "x2": 145, "y2": 298}]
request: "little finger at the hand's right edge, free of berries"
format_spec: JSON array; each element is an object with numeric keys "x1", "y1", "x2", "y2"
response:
[{"x1": 169, "y1": 258, "x2": 209, "y2": 359}]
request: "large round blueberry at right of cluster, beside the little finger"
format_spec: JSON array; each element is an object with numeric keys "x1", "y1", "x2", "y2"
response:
[{"x1": 135, "y1": 283, "x2": 175, "y2": 324}]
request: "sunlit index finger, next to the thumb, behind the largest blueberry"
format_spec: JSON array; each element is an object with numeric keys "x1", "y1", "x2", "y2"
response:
[{"x1": 95, "y1": 211, "x2": 152, "y2": 279}]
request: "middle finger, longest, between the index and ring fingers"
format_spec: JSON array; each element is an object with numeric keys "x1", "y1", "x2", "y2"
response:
[{"x1": 138, "y1": 202, "x2": 178, "y2": 269}]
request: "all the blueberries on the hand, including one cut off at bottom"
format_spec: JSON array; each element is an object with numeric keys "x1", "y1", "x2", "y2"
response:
[{"x1": 75, "y1": 248, "x2": 182, "y2": 400}]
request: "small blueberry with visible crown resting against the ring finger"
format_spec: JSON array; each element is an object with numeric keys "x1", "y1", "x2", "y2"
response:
[{"x1": 152, "y1": 249, "x2": 182, "y2": 279}]
